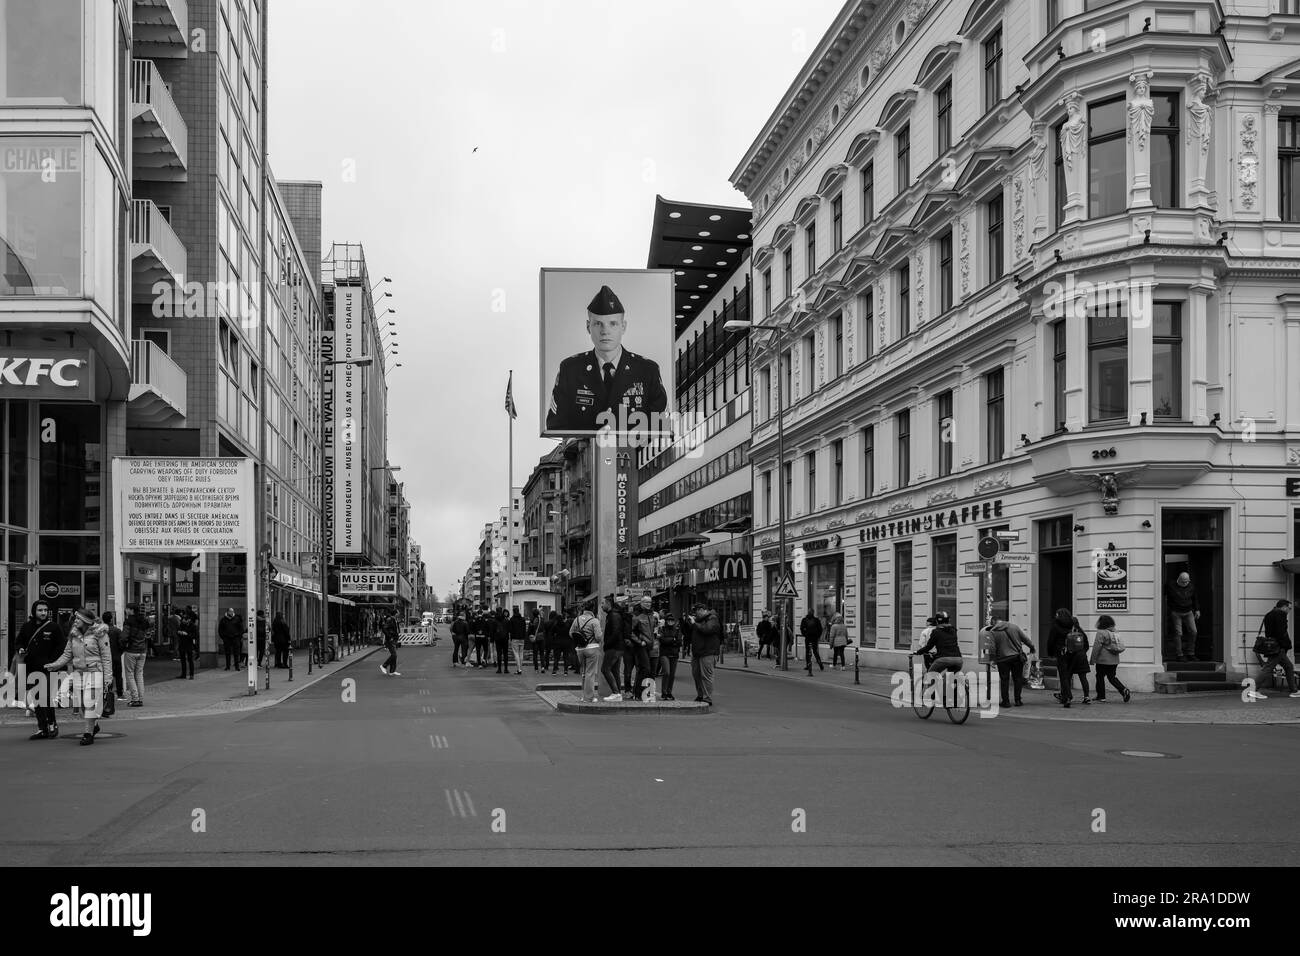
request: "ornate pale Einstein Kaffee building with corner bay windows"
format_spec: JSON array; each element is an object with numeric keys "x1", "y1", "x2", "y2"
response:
[{"x1": 732, "y1": 0, "x2": 1300, "y2": 689}]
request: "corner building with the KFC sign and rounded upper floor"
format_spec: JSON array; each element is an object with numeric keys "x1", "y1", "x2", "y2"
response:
[{"x1": 0, "y1": 0, "x2": 139, "y2": 661}]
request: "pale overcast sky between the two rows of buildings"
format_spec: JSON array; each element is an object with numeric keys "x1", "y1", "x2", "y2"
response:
[{"x1": 268, "y1": 0, "x2": 841, "y2": 597}]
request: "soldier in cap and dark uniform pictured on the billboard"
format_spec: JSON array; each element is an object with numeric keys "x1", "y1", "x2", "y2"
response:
[{"x1": 546, "y1": 285, "x2": 668, "y2": 432}]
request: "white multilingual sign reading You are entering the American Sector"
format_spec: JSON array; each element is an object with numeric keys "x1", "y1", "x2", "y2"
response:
[{"x1": 113, "y1": 458, "x2": 255, "y2": 551}]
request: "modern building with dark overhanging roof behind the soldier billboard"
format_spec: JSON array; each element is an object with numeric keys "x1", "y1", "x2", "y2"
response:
[{"x1": 632, "y1": 196, "x2": 753, "y2": 624}]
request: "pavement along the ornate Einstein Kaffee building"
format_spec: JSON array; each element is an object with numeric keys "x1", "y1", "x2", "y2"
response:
[{"x1": 719, "y1": 648, "x2": 1300, "y2": 724}]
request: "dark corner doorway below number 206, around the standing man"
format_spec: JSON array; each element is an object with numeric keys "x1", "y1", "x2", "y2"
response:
[{"x1": 1156, "y1": 509, "x2": 1227, "y2": 661}]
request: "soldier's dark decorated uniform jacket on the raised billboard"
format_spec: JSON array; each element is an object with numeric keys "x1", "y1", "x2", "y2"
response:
[{"x1": 546, "y1": 349, "x2": 668, "y2": 432}]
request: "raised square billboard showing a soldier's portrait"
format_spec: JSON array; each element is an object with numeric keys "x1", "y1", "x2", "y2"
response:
[{"x1": 540, "y1": 269, "x2": 677, "y2": 445}]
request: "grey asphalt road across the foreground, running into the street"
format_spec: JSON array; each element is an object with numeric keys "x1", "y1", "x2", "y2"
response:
[{"x1": 0, "y1": 648, "x2": 1300, "y2": 866}]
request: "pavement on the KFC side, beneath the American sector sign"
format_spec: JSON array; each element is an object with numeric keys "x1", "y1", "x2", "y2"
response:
[{"x1": 0, "y1": 645, "x2": 384, "y2": 730}]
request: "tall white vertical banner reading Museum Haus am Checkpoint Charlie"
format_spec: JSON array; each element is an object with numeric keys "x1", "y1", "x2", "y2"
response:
[{"x1": 328, "y1": 286, "x2": 367, "y2": 554}]
